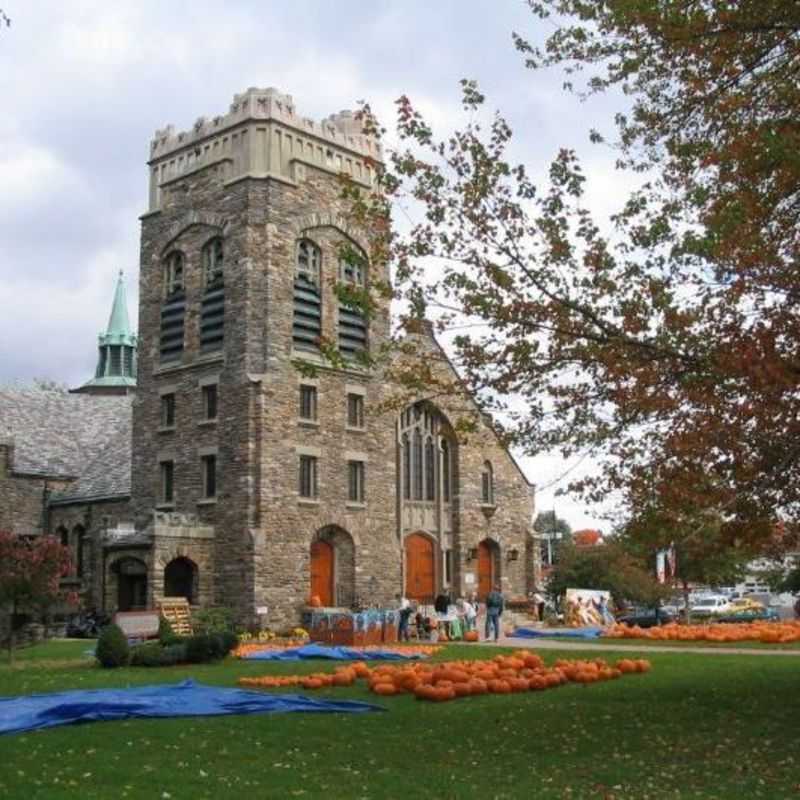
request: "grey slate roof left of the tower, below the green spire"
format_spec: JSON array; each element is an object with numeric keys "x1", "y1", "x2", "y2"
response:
[{"x1": 0, "y1": 387, "x2": 134, "y2": 502}]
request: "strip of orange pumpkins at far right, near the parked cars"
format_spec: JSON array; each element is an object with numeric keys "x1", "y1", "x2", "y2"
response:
[{"x1": 603, "y1": 620, "x2": 800, "y2": 644}]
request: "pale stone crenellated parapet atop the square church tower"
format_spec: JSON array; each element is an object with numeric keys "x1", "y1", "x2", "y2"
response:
[{"x1": 149, "y1": 87, "x2": 382, "y2": 212}]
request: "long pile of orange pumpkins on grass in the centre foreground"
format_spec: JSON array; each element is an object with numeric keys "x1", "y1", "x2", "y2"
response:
[{"x1": 239, "y1": 650, "x2": 650, "y2": 702}]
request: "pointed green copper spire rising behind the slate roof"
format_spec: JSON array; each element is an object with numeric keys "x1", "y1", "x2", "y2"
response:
[{"x1": 75, "y1": 270, "x2": 137, "y2": 394}]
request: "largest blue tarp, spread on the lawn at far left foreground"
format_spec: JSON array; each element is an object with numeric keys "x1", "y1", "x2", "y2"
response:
[{"x1": 0, "y1": 680, "x2": 385, "y2": 734}]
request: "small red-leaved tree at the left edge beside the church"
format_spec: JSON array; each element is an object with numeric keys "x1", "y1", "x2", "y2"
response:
[{"x1": 0, "y1": 531, "x2": 72, "y2": 662}]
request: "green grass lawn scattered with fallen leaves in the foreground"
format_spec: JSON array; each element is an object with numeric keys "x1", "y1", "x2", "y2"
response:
[{"x1": 0, "y1": 642, "x2": 800, "y2": 800}]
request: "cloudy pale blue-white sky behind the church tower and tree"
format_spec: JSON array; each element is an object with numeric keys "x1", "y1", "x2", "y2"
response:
[{"x1": 0, "y1": 0, "x2": 624, "y2": 530}]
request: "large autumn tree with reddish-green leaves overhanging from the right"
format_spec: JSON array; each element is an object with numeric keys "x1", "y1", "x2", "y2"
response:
[{"x1": 354, "y1": 0, "x2": 800, "y2": 540}]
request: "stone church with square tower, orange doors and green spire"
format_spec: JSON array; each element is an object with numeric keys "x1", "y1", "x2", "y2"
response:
[{"x1": 0, "y1": 88, "x2": 539, "y2": 627}]
